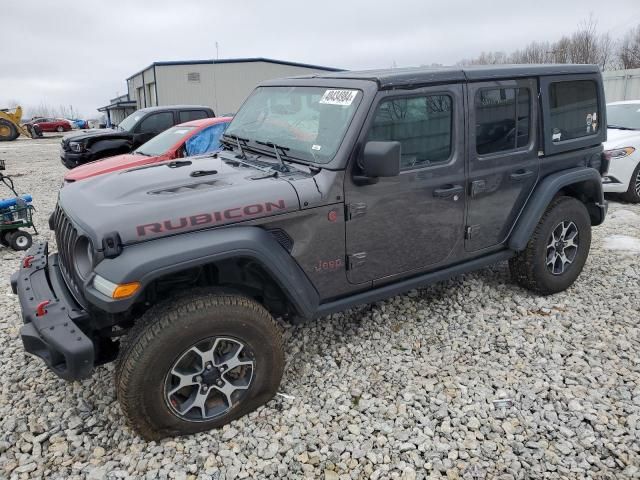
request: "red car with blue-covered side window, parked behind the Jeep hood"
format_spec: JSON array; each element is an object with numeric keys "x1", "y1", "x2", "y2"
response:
[{"x1": 64, "y1": 117, "x2": 231, "y2": 182}]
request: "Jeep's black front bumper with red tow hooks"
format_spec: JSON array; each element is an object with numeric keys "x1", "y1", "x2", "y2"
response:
[{"x1": 11, "y1": 242, "x2": 95, "y2": 380}]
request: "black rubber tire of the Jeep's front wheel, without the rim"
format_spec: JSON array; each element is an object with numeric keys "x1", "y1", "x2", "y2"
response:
[{"x1": 115, "y1": 292, "x2": 284, "y2": 440}]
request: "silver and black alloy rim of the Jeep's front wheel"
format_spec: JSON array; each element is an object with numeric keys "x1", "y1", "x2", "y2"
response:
[{"x1": 164, "y1": 337, "x2": 255, "y2": 422}]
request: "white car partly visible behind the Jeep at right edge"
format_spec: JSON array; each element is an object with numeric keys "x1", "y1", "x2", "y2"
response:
[{"x1": 603, "y1": 100, "x2": 640, "y2": 203}]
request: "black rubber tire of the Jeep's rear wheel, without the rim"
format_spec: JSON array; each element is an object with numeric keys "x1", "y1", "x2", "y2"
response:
[{"x1": 509, "y1": 197, "x2": 591, "y2": 295}]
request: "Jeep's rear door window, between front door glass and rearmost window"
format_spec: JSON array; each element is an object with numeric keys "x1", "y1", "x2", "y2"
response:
[{"x1": 475, "y1": 88, "x2": 531, "y2": 155}]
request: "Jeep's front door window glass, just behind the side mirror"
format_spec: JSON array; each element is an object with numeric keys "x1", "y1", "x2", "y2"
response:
[{"x1": 367, "y1": 95, "x2": 453, "y2": 170}]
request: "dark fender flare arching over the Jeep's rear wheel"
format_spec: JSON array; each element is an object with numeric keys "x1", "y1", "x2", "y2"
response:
[{"x1": 508, "y1": 167, "x2": 607, "y2": 252}]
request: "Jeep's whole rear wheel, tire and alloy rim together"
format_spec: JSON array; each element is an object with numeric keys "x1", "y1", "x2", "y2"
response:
[{"x1": 509, "y1": 197, "x2": 591, "y2": 295}]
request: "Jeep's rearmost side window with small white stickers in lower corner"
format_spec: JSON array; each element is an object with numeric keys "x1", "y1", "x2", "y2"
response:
[{"x1": 547, "y1": 80, "x2": 600, "y2": 143}]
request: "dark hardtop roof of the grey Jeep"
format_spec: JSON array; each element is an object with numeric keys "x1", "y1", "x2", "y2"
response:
[{"x1": 296, "y1": 64, "x2": 600, "y2": 88}]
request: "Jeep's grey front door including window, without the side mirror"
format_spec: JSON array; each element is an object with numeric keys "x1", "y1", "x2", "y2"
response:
[{"x1": 345, "y1": 85, "x2": 465, "y2": 283}]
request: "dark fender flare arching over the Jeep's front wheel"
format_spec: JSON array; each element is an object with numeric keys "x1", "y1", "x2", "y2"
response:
[{"x1": 85, "y1": 226, "x2": 319, "y2": 318}]
